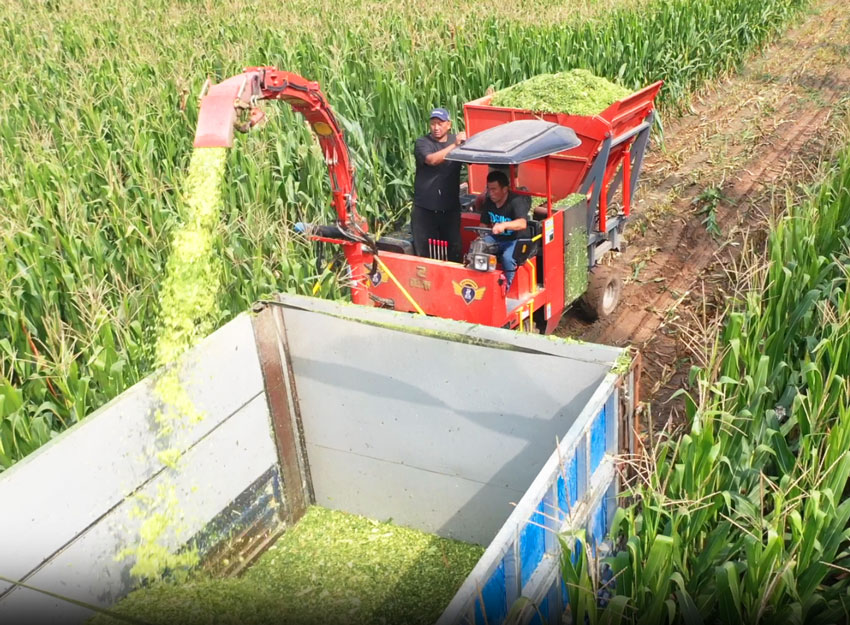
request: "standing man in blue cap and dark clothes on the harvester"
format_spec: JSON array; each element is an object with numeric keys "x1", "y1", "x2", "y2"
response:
[{"x1": 410, "y1": 108, "x2": 466, "y2": 263}]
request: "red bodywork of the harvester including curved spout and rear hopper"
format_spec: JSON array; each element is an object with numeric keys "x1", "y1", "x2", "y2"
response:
[{"x1": 195, "y1": 67, "x2": 661, "y2": 332}]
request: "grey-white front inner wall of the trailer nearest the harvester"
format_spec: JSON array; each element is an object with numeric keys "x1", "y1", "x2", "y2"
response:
[{"x1": 284, "y1": 300, "x2": 622, "y2": 545}]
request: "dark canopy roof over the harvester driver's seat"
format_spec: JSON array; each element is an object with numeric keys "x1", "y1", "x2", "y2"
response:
[{"x1": 446, "y1": 119, "x2": 581, "y2": 165}]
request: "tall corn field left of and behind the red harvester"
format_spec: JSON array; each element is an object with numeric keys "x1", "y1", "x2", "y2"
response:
[{"x1": 0, "y1": 0, "x2": 805, "y2": 470}]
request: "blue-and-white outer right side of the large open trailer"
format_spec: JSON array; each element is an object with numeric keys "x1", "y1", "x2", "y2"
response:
[{"x1": 437, "y1": 368, "x2": 636, "y2": 625}]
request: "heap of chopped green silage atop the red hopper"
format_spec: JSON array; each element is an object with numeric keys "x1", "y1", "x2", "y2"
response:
[{"x1": 490, "y1": 69, "x2": 631, "y2": 115}]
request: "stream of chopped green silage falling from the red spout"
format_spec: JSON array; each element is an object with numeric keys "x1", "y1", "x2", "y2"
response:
[{"x1": 118, "y1": 148, "x2": 227, "y2": 580}]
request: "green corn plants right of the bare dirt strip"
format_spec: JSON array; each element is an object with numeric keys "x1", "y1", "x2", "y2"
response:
[{"x1": 562, "y1": 145, "x2": 850, "y2": 623}]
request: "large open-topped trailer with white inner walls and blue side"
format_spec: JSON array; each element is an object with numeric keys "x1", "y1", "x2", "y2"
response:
[{"x1": 0, "y1": 295, "x2": 637, "y2": 625}]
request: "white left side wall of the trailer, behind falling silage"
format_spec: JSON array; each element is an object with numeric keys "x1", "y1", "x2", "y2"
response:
[{"x1": 0, "y1": 316, "x2": 277, "y2": 624}]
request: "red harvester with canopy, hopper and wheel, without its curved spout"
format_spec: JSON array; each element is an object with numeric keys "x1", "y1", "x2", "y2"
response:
[{"x1": 364, "y1": 81, "x2": 663, "y2": 334}]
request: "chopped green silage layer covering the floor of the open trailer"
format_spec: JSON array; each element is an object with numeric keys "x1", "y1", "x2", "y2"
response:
[{"x1": 93, "y1": 507, "x2": 484, "y2": 625}]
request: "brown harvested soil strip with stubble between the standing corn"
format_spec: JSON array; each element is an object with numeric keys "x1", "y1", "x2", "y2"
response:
[{"x1": 556, "y1": 0, "x2": 850, "y2": 428}]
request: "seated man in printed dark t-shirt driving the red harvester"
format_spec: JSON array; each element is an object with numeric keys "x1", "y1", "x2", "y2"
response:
[{"x1": 475, "y1": 171, "x2": 528, "y2": 293}]
